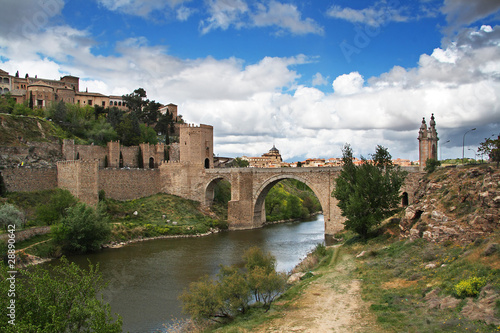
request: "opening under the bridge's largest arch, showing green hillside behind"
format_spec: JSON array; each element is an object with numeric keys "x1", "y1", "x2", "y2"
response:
[{"x1": 253, "y1": 176, "x2": 323, "y2": 226}]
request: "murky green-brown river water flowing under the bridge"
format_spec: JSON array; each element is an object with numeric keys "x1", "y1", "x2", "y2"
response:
[{"x1": 53, "y1": 215, "x2": 324, "y2": 333}]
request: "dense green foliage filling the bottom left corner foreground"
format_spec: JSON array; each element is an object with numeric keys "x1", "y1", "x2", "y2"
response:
[{"x1": 0, "y1": 258, "x2": 122, "y2": 333}]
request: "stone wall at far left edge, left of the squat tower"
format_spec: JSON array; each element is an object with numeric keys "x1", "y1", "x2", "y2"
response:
[{"x1": 0, "y1": 167, "x2": 57, "y2": 192}]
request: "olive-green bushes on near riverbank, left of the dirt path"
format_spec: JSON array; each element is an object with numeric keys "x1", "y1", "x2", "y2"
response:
[{"x1": 179, "y1": 248, "x2": 286, "y2": 322}]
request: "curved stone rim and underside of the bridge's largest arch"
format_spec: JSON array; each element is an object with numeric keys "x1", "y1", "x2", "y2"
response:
[{"x1": 252, "y1": 174, "x2": 327, "y2": 227}]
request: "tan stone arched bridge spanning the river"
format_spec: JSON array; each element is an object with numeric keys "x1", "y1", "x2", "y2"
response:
[{"x1": 162, "y1": 163, "x2": 422, "y2": 235}]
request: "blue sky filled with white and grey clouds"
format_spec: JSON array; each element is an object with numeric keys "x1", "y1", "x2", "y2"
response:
[{"x1": 0, "y1": 0, "x2": 500, "y2": 162}]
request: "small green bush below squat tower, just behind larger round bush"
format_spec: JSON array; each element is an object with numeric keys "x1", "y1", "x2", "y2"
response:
[{"x1": 36, "y1": 189, "x2": 78, "y2": 225}]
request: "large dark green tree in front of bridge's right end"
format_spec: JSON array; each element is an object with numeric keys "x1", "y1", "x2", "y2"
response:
[{"x1": 333, "y1": 144, "x2": 406, "y2": 238}]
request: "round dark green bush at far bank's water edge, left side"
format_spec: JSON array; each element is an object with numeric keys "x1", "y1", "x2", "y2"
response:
[{"x1": 52, "y1": 203, "x2": 111, "y2": 253}]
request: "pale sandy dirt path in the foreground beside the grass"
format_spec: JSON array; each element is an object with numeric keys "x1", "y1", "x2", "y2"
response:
[{"x1": 255, "y1": 246, "x2": 380, "y2": 333}]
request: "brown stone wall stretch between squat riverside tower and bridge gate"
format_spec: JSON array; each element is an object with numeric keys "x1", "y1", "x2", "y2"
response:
[{"x1": 99, "y1": 168, "x2": 161, "y2": 200}]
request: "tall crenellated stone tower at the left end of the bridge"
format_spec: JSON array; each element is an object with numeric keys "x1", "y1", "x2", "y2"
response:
[{"x1": 179, "y1": 124, "x2": 214, "y2": 169}]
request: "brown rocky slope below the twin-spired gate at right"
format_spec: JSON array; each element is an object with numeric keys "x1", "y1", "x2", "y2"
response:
[{"x1": 400, "y1": 164, "x2": 500, "y2": 244}]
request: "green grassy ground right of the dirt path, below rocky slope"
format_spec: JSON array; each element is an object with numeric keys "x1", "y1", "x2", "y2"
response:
[{"x1": 345, "y1": 224, "x2": 500, "y2": 332}]
